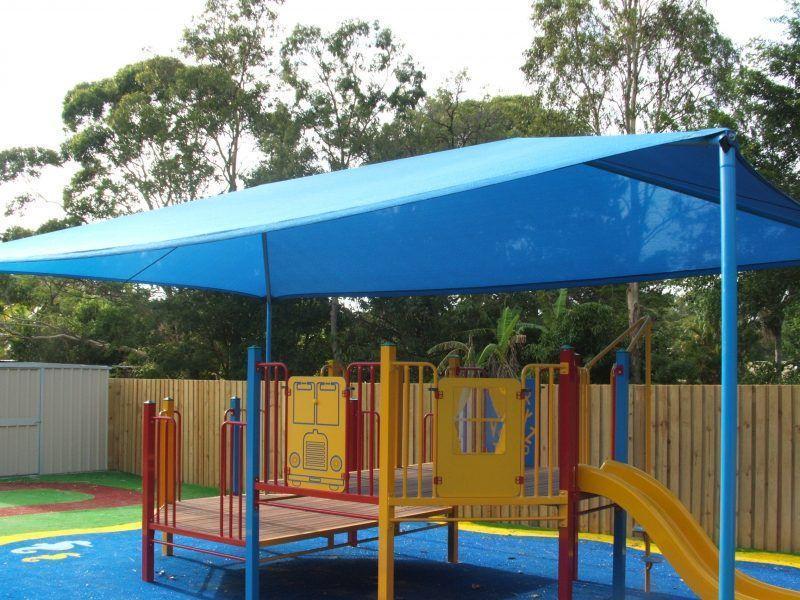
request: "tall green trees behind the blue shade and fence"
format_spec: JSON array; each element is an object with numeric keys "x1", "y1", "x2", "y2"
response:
[{"x1": 0, "y1": 0, "x2": 800, "y2": 382}]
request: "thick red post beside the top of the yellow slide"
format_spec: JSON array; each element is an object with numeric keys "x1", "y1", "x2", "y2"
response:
[{"x1": 558, "y1": 346, "x2": 580, "y2": 600}]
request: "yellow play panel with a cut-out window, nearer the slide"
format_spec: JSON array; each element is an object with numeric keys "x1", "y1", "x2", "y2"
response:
[{"x1": 436, "y1": 377, "x2": 525, "y2": 498}]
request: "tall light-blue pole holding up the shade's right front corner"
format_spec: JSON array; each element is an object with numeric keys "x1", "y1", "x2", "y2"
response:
[{"x1": 719, "y1": 132, "x2": 738, "y2": 600}]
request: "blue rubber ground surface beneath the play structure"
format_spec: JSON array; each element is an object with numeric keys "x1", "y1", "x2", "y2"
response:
[{"x1": 0, "y1": 529, "x2": 800, "y2": 600}]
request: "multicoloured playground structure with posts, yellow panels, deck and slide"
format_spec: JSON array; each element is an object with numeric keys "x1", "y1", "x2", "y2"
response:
[{"x1": 142, "y1": 318, "x2": 800, "y2": 600}]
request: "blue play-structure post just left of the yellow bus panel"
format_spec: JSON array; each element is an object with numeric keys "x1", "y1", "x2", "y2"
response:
[{"x1": 245, "y1": 346, "x2": 262, "y2": 600}]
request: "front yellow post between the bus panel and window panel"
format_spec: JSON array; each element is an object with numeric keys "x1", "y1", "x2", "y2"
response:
[{"x1": 378, "y1": 342, "x2": 399, "y2": 600}]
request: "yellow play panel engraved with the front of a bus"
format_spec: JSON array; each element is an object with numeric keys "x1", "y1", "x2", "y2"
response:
[{"x1": 286, "y1": 377, "x2": 347, "y2": 492}]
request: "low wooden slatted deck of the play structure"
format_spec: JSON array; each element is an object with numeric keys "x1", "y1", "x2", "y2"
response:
[{"x1": 153, "y1": 495, "x2": 451, "y2": 546}]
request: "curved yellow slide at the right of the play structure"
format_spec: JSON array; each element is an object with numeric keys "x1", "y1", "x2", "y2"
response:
[{"x1": 578, "y1": 460, "x2": 800, "y2": 600}]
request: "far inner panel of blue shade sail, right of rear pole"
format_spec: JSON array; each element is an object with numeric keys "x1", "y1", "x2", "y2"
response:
[{"x1": 269, "y1": 165, "x2": 800, "y2": 297}]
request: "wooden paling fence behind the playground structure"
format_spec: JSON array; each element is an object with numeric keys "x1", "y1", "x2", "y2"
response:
[{"x1": 108, "y1": 379, "x2": 800, "y2": 552}]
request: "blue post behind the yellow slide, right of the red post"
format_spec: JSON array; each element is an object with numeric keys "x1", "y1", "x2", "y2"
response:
[{"x1": 612, "y1": 350, "x2": 631, "y2": 598}]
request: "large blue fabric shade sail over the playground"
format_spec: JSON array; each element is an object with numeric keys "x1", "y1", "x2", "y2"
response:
[{"x1": 0, "y1": 129, "x2": 800, "y2": 298}]
